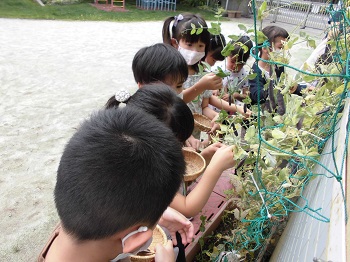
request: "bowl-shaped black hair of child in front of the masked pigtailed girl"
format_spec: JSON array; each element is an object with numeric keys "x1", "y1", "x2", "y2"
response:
[{"x1": 132, "y1": 43, "x2": 188, "y2": 84}]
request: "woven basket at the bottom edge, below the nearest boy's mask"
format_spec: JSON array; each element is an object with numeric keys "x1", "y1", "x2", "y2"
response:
[{"x1": 130, "y1": 225, "x2": 168, "y2": 262}]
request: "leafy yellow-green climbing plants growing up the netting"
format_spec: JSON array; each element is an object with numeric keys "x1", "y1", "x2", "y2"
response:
[{"x1": 192, "y1": 3, "x2": 350, "y2": 261}]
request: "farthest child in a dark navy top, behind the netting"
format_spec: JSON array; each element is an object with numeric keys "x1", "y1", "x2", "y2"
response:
[{"x1": 249, "y1": 26, "x2": 314, "y2": 105}]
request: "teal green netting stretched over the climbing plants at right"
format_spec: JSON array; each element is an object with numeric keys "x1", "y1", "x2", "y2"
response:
[{"x1": 209, "y1": 0, "x2": 350, "y2": 261}]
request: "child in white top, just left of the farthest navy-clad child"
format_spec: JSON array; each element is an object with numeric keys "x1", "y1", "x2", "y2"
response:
[{"x1": 222, "y1": 35, "x2": 253, "y2": 105}]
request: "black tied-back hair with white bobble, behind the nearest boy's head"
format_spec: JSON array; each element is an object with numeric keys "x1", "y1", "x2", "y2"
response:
[{"x1": 105, "y1": 83, "x2": 194, "y2": 143}]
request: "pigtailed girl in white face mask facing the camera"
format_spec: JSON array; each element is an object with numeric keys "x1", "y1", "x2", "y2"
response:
[{"x1": 163, "y1": 13, "x2": 222, "y2": 143}]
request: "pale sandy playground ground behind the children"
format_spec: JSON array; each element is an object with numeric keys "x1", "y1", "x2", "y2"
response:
[{"x1": 0, "y1": 19, "x2": 321, "y2": 261}]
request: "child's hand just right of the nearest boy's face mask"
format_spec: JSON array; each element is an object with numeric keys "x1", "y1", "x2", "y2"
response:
[{"x1": 158, "y1": 207, "x2": 194, "y2": 246}]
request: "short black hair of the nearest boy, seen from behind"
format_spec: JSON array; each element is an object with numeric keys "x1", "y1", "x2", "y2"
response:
[{"x1": 54, "y1": 107, "x2": 185, "y2": 241}]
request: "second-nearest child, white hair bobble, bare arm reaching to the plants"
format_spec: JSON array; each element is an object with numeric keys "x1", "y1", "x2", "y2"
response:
[{"x1": 107, "y1": 84, "x2": 234, "y2": 217}]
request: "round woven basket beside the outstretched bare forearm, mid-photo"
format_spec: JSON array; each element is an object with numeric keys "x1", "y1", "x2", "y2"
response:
[{"x1": 182, "y1": 148, "x2": 206, "y2": 182}]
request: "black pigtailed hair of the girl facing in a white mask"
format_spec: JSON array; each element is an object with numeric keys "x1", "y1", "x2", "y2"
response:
[{"x1": 162, "y1": 13, "x2": 210, "y2": 71}]
